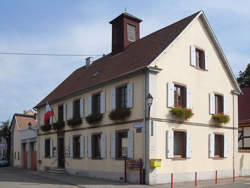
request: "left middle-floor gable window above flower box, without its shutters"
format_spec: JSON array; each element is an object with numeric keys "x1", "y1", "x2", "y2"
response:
[{"x1": 174, "y1": 85, "x2": 186, "y2": 107}]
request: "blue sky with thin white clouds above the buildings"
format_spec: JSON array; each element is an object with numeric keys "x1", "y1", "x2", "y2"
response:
[{"x1": 0, "y1": 0, "x2": 250, "y2": 122}]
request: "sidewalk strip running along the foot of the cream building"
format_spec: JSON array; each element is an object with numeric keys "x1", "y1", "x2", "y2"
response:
[{"x1": 28, "y1": 171, "x2": 250, "y2": 188}]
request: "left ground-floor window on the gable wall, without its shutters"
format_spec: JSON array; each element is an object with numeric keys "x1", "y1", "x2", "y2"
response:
[{"x1": 174, "y1": 131, "x2": 186, "y2": 158}]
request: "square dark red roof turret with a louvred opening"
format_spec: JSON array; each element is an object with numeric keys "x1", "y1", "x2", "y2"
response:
[{"x1": 109, "y1": 12, "x2": 142, "y2": 55}]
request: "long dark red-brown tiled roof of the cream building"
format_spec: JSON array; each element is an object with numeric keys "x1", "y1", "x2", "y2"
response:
[{"x1": 36, "y1": 12, "x2": 200, "y2": 108}]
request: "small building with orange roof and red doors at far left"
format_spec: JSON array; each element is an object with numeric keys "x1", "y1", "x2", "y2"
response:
[{"x1": 10, "y1": 110, "x2": 37, "y2": 170}]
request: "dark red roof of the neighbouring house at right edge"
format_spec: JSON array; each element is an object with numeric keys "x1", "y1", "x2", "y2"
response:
[{"x1": 238, "y1": 88, "x2": 250, "y2": 124}]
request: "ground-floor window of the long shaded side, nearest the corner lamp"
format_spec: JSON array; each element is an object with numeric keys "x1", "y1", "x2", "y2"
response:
[{"x1": 117, "y1": 131, "x2": 128, "y2": 159}]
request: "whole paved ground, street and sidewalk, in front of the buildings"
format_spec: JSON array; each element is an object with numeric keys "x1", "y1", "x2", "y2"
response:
[{"x1": 0, "y1": 167, "x2": 250, "y2": 188}]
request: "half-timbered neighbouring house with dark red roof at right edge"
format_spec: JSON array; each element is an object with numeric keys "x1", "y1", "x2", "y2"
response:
[{"x1": 239, "y1": 88, "x2": 250, "y2": 151}]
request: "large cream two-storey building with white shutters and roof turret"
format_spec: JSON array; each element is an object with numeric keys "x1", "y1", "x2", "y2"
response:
[{"x1": 36, "y1": 11, "x2": 241, "y2": 184}]
